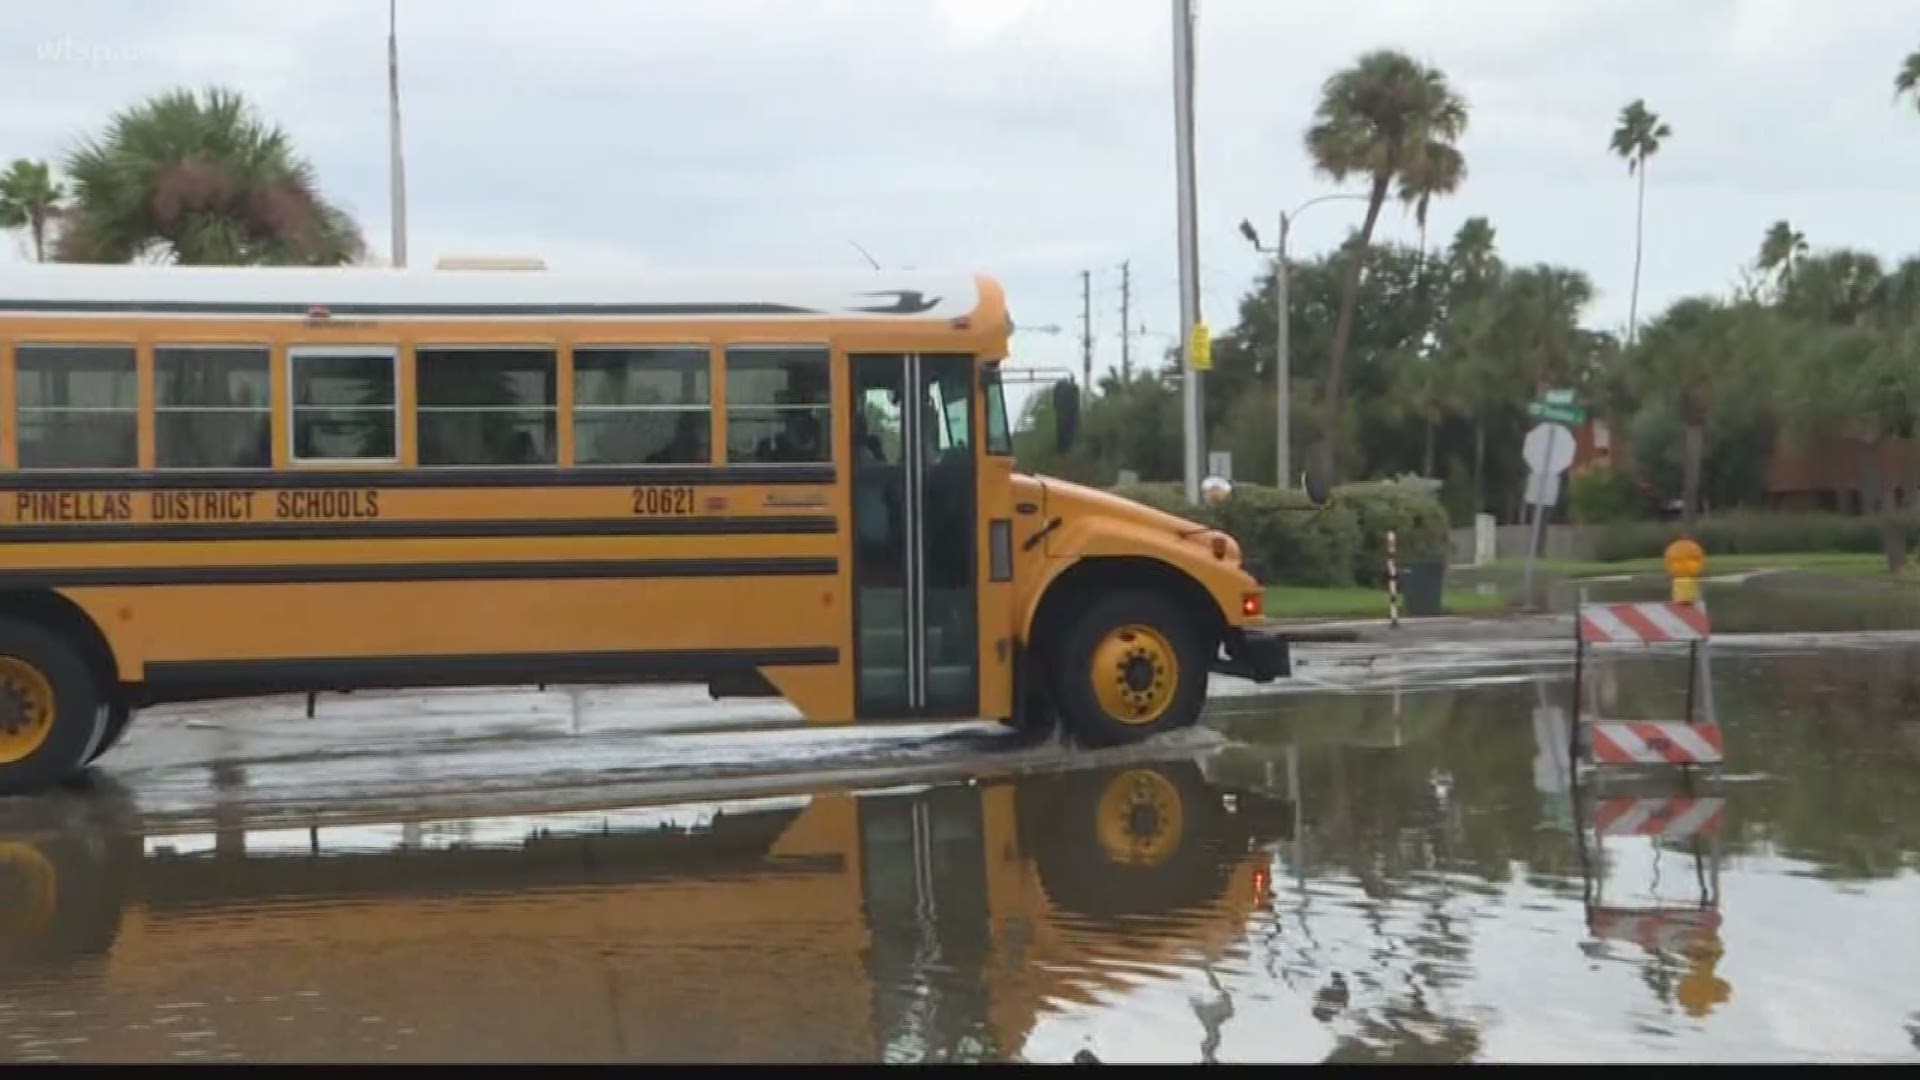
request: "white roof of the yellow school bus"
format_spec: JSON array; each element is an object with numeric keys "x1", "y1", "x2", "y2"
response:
[{"x1": 0, "y1": 263, "x2": 981, "y2": 319}]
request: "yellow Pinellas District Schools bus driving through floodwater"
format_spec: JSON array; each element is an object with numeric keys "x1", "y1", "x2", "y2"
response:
[{"x1": 0, "y1": 265, "x2": 1286, "y2": 792}]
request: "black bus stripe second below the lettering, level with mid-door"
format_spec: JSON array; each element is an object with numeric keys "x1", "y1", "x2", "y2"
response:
[{"x1": 0, "y1": 557, "x2": 839, "y2": 588}]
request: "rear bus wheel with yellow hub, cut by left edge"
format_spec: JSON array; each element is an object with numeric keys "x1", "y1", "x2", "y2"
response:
[{"x1": 0, "y1": 619, "x2": 108, "y2": 796}]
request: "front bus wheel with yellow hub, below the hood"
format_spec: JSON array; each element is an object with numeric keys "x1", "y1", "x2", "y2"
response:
[{"x1": 1052, "y1": 588, "x2": 1210, "y2": 746}]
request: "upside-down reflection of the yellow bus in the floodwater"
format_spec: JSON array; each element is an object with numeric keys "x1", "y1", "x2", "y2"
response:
[{"x1": 0, "y1": 763, "x2": 1292, "y2": 1061}]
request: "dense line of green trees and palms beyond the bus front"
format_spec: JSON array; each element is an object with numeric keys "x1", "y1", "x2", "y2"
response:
[{"x1": 1020, "y1": 52, "x2": 1920, "y2": 528}]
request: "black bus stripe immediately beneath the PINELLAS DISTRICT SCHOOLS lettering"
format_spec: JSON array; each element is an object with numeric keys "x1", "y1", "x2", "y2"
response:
[{"x1": 0, "y1": 517, "x2": 839, "y2": 544}]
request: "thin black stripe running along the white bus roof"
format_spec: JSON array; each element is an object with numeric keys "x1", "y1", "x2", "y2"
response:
[{"x1": 0, "y1": 300, "x2": 821, "y2": 315}]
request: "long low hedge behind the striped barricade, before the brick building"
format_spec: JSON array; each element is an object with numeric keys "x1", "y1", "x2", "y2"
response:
[{"x1": 1594, "y1": 511, "x2": 1920, "y2": 563}]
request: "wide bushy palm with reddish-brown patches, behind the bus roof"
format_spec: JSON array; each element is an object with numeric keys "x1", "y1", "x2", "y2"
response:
[{"x1": 58, "y1": 88, "x2": 365, "y2": 265}]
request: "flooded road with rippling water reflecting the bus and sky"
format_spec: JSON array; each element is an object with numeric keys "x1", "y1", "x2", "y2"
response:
[{"x1": 0, "y1": 636, "x2": 1920, "y2": 1063}]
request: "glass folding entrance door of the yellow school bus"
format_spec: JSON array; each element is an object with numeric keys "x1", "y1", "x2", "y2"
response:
[{"x1": 849, "y1": 354, "x2": 979, "y2": 719}]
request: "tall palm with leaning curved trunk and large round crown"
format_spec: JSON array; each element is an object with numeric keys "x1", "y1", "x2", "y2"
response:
[{"x1": 1306, "y1": 50, "x2": 1467, "y2": 482}]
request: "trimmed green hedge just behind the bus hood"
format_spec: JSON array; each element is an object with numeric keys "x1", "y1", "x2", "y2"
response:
[{"x1": 1116, "y1": 482, "x2": 1448, "y2": 586}]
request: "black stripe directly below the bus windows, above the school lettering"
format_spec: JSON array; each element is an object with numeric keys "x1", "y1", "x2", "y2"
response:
[{"x1": 0, "y1": 465, "x2": 833, "y2": 492}]
